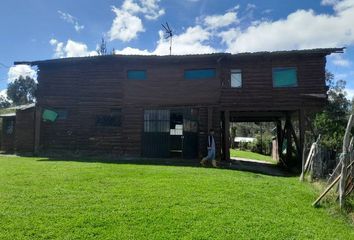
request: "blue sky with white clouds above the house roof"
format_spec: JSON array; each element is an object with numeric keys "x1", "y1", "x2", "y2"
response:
[{"x1": 0, "y1": 0, "x2": 354, "y2": 97}]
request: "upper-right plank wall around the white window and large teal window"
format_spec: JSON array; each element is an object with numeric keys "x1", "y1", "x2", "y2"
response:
[{"x1": 220, "y1": 56, "x2": 326, "y2": 111}]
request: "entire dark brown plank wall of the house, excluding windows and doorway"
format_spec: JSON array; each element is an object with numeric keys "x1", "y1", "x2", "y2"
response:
[{"x1": 38, "y1": 53, "x2": 326, "y2": 156}]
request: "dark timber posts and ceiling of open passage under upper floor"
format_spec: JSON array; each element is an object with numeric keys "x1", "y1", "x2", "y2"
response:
[{"x1": 219, "y1": 109, "x2": 305, "y2": 169}]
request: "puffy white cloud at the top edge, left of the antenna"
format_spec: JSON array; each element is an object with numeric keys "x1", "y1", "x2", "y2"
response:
[{"x1": 108, "y1": 0, "x2": 165, "y2": 42}]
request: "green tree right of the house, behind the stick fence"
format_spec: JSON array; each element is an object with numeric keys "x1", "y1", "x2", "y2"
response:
[{"x1": 313, "y1": 72, "x2": 350, "y2": 150}]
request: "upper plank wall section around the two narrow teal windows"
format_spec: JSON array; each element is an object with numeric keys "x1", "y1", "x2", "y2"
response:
[{"x1": 123, "y1": 59, "x2": 220, "y2": 107}]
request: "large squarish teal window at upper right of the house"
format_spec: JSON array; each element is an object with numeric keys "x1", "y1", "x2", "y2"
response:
[{"x1": 273, "y1": 67, "x2": 297, "y2": 87}]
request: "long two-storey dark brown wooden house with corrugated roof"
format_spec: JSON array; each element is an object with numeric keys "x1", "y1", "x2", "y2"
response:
[{"x1": 15, "y1": 48, "x2": 343, "y2": 166}]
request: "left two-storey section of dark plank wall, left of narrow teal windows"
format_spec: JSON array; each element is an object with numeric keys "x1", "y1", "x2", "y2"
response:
[{"x1": 38, "y1": 64, "x2": 123, "y2": 153}]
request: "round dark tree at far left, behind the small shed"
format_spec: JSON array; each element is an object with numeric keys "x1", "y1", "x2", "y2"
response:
[{"x1": 7, "y1": 76, "x2": 37, "y2": 106}]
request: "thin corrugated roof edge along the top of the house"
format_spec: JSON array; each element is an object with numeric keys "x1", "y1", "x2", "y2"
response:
[{"x1": 14, "y1": 48, "x2": 344, "y2": 66}]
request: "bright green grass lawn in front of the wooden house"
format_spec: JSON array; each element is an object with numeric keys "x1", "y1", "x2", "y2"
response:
[{"x1": 0, "y1": 157, "x2": 354, "y2": 240}]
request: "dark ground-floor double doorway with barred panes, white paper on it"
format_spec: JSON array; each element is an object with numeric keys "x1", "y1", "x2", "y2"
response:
[{"x1": 142, "y1": 108, "x2": 198, "y2": 159}]
